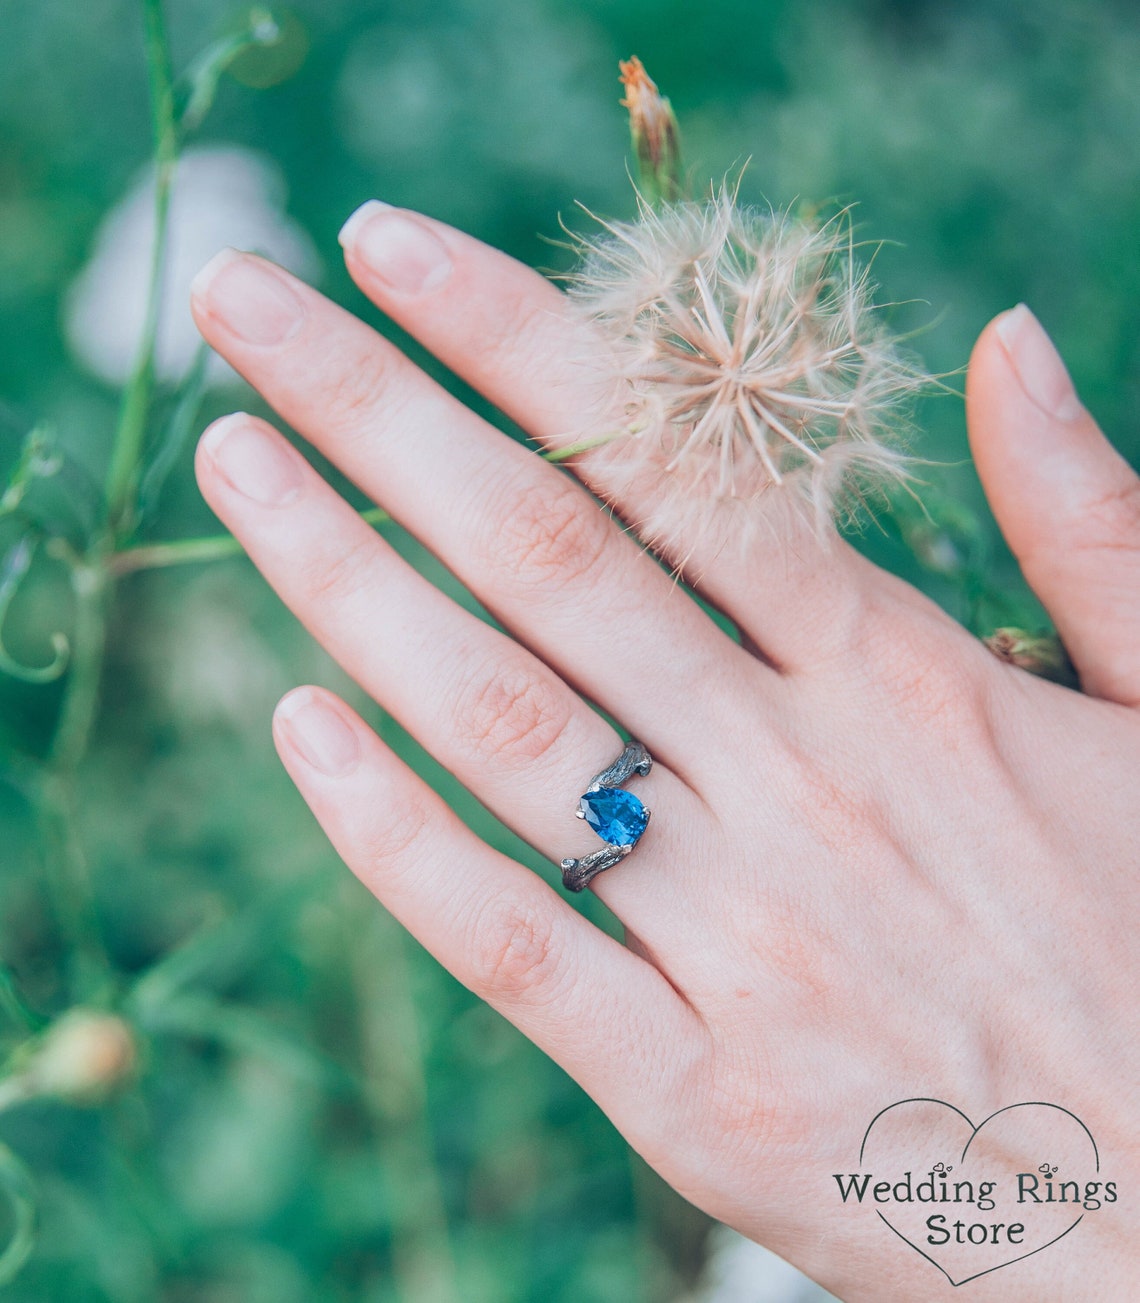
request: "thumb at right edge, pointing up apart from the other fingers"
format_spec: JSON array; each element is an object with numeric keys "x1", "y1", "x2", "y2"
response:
[{"x1": 967, "y1": 305, "x2": 1140, "y2": 705}]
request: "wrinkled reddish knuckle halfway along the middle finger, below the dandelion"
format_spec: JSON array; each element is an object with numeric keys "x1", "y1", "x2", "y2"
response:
[{"x1": 489, "y1": 476, "x2": 611, "y2": 589}]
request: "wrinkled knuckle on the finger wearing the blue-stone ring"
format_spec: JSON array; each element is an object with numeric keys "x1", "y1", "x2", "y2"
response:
[{"x1": 455, "y1": 662, "x2": 571, "y2": 761}]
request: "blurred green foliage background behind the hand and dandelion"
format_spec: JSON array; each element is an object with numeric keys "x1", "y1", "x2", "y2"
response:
[{"x1": 0, "y1": 0, "x2": 1140, "y2": 1303}]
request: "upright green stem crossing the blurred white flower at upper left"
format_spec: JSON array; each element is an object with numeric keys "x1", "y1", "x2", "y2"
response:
[{"x1": 107, "y1": 0, "x2": 178, "y2": 538}]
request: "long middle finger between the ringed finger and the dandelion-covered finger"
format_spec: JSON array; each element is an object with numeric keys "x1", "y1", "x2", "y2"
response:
[{"x1": 187, "y1": 253, "x2": 756, "y2": 777}]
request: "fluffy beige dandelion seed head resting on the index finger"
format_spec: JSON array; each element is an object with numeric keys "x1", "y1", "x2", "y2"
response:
[{"x1": 569, "y1": 188, "x2": 928, "y2": 554}]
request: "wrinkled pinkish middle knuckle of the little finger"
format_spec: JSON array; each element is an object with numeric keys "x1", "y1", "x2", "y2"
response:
[{"x1": 470, "y1": 893, "x2": 563, "y2": 1002}]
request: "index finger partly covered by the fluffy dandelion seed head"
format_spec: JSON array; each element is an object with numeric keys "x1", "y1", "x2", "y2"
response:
[{"x1": 341, "y1": 203, "x2": 879, "y2": 668}]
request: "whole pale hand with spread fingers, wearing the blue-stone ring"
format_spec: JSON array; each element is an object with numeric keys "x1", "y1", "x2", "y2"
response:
[{"x1": 194, "y1": 210, "x2": 1140, "y2": 1303}]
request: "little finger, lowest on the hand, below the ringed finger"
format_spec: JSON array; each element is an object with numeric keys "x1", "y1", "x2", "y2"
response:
[{"x1": 274, "y1": 688, "x2": 701, "y2": 1143}]
